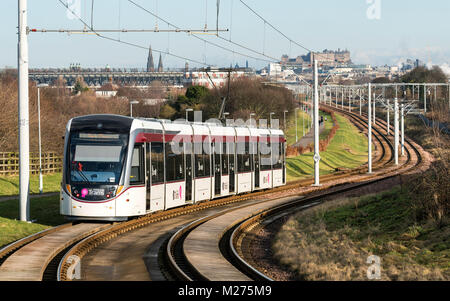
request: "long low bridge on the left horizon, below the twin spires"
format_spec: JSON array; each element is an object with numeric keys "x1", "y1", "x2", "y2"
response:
[{"x1": 29, "y1": 70, "x2": 185, "y2": 86}]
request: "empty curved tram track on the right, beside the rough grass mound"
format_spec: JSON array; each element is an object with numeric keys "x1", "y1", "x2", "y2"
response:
[{"x1": 166, "y1": 105, "x2": 423, "y2": 281}]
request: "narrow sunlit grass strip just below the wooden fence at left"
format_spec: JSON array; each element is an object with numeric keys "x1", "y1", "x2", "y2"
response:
[{"x1": 0, "y1": 173, "x2": 61, "y2": 196}]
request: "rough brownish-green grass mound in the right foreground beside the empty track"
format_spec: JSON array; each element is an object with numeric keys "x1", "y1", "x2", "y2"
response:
[{"x1": 275, "y1": 187, "x2": 450, "y2": 280}]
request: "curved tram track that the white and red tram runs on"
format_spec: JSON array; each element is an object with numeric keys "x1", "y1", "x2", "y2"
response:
[{"x1": 0, "y1": 104, "x2": 428, "y2": 280}]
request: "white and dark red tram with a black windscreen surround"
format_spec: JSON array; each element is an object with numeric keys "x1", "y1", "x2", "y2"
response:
[{"x1": 60, "y1": 115, "x2": 286, "y2": 221}]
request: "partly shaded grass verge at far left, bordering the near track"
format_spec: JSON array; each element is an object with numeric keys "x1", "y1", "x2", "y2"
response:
[{"x1": 0, "y1": 196, "x2": 64, "y2": 246}]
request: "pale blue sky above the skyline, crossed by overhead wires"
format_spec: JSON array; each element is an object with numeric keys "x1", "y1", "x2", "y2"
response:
[{"x1": 0, "y1": 0, "x2": 450, "y2": 68}]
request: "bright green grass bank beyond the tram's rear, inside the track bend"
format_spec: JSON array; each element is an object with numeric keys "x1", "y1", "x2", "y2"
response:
[{"x1": 286, "y1": 114, "x2": 367, "y2": 181}]
